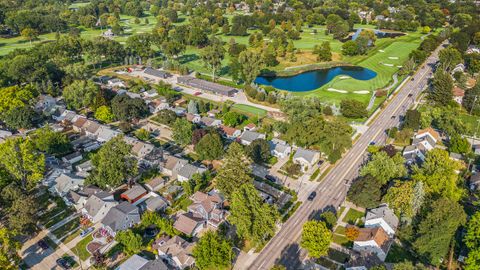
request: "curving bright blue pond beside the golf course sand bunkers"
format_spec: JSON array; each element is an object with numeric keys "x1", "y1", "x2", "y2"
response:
[{"x1": 255, "y1": 66, "x2": 377, "y2": 92}]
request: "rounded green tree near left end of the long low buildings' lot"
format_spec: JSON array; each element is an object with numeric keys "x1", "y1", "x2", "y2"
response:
[{"x1": 62, "y1": 80, "x2": 99, "y2": 110}]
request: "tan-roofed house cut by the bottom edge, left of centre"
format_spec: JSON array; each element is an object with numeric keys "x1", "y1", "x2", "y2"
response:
[{"x1": 152, "y1": 236, "x2": 195, "y2": 269}]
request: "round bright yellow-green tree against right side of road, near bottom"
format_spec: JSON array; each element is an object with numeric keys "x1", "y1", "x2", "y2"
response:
[{"x1": 300, "y1": 220, "x2": 332, "y2": 258}]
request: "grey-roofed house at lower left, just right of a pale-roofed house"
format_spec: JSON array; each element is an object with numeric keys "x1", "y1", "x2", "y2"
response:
[{"x1": 102, "y1": 202, "x2": 140, "y2": 236}]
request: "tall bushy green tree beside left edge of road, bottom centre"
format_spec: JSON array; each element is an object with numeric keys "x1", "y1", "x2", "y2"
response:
[{"x1": 229, "y1": 184, "x2": 278, "y2": 246}]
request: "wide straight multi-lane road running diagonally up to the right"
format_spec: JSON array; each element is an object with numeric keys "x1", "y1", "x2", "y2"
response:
[{"x1": 249, "y1": 43, "x2": 441, "y2": 270}]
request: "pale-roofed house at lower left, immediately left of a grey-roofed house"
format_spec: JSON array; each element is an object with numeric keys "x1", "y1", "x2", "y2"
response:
[{"x1": 82, "y1": 191, "x2": 118, "y2": 223}]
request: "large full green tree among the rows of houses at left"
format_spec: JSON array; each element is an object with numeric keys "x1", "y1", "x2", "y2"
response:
[{"x1": 86, "y1": 136, "x2": 137, "y2": 188}]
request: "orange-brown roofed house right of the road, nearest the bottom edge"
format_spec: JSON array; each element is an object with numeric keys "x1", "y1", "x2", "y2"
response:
[{"x1": 353, "y1": 227, "x2": 391, "y2": 261}]
